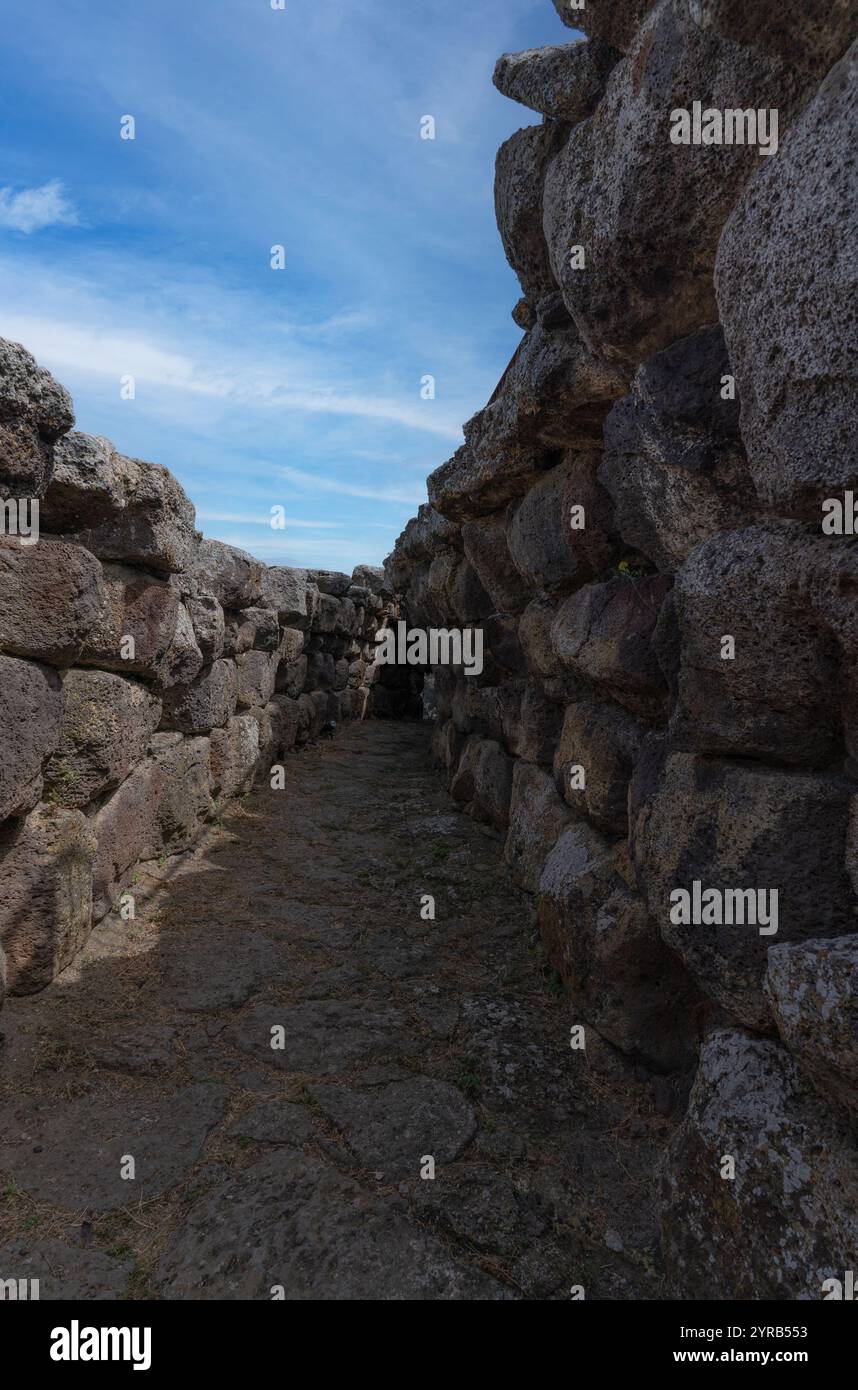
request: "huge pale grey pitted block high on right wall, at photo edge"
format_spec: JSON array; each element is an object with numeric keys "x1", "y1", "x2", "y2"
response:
[{"x1": 716, "y1": 43, "x2": 858, "y2": 523}]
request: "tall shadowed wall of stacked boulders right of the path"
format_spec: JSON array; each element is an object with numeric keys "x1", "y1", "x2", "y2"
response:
[{"x1": 387, "y1": 0, "x2": 858, "y2": 1298}]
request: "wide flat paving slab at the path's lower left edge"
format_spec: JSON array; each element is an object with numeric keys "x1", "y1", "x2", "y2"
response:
[{"x1": 0, "y1": 1084, "x2": 227, "y2": 1211}]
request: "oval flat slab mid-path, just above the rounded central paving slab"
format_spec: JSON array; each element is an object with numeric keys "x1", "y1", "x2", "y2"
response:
[{"x1": 227, "y1": 999, "x2": 414, "y2": 1076}]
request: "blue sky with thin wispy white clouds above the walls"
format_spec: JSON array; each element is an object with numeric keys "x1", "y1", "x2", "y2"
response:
[{"x1": 0, "y1": 0, "x2": 573, "y2": 570}]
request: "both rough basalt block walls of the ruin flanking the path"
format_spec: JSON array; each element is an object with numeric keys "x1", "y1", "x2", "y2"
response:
[{"x1": 0, "y1": 0, "x2": 858, "y2": 1300}]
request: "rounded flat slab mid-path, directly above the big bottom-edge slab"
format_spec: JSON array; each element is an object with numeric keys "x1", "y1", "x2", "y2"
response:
[{"x1": 310, "y1": 1076, "x2": 477, "y2": 1179}]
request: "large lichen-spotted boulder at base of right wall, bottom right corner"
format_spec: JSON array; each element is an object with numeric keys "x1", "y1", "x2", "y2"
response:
[{"x1": 661, "y1": 1029, "x2": 858, "y2": 1302}]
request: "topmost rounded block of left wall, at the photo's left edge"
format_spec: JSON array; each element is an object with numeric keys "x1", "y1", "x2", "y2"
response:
[{"x1": 0, "y1": 338, "x2": 75, "y2": 498}]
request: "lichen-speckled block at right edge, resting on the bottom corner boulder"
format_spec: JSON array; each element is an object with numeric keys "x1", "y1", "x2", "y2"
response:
[{"x1": 766, "y1": 935, "x2": 858, "y2": 1109}]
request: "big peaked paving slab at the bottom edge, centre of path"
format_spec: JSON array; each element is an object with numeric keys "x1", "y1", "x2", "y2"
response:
[{"x1": 156, "y1": 1152, "x2": 510, "y2": 1301}]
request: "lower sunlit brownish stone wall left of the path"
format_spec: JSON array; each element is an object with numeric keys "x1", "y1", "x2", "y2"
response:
[{"x1": 0, "y1": 339, "x2": 395, "y2": 999}]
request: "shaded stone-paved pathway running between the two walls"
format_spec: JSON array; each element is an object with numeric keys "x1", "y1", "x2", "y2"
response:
[{"x1": 0, "y1": 723, "x2": 672, "y2": 1300}]
